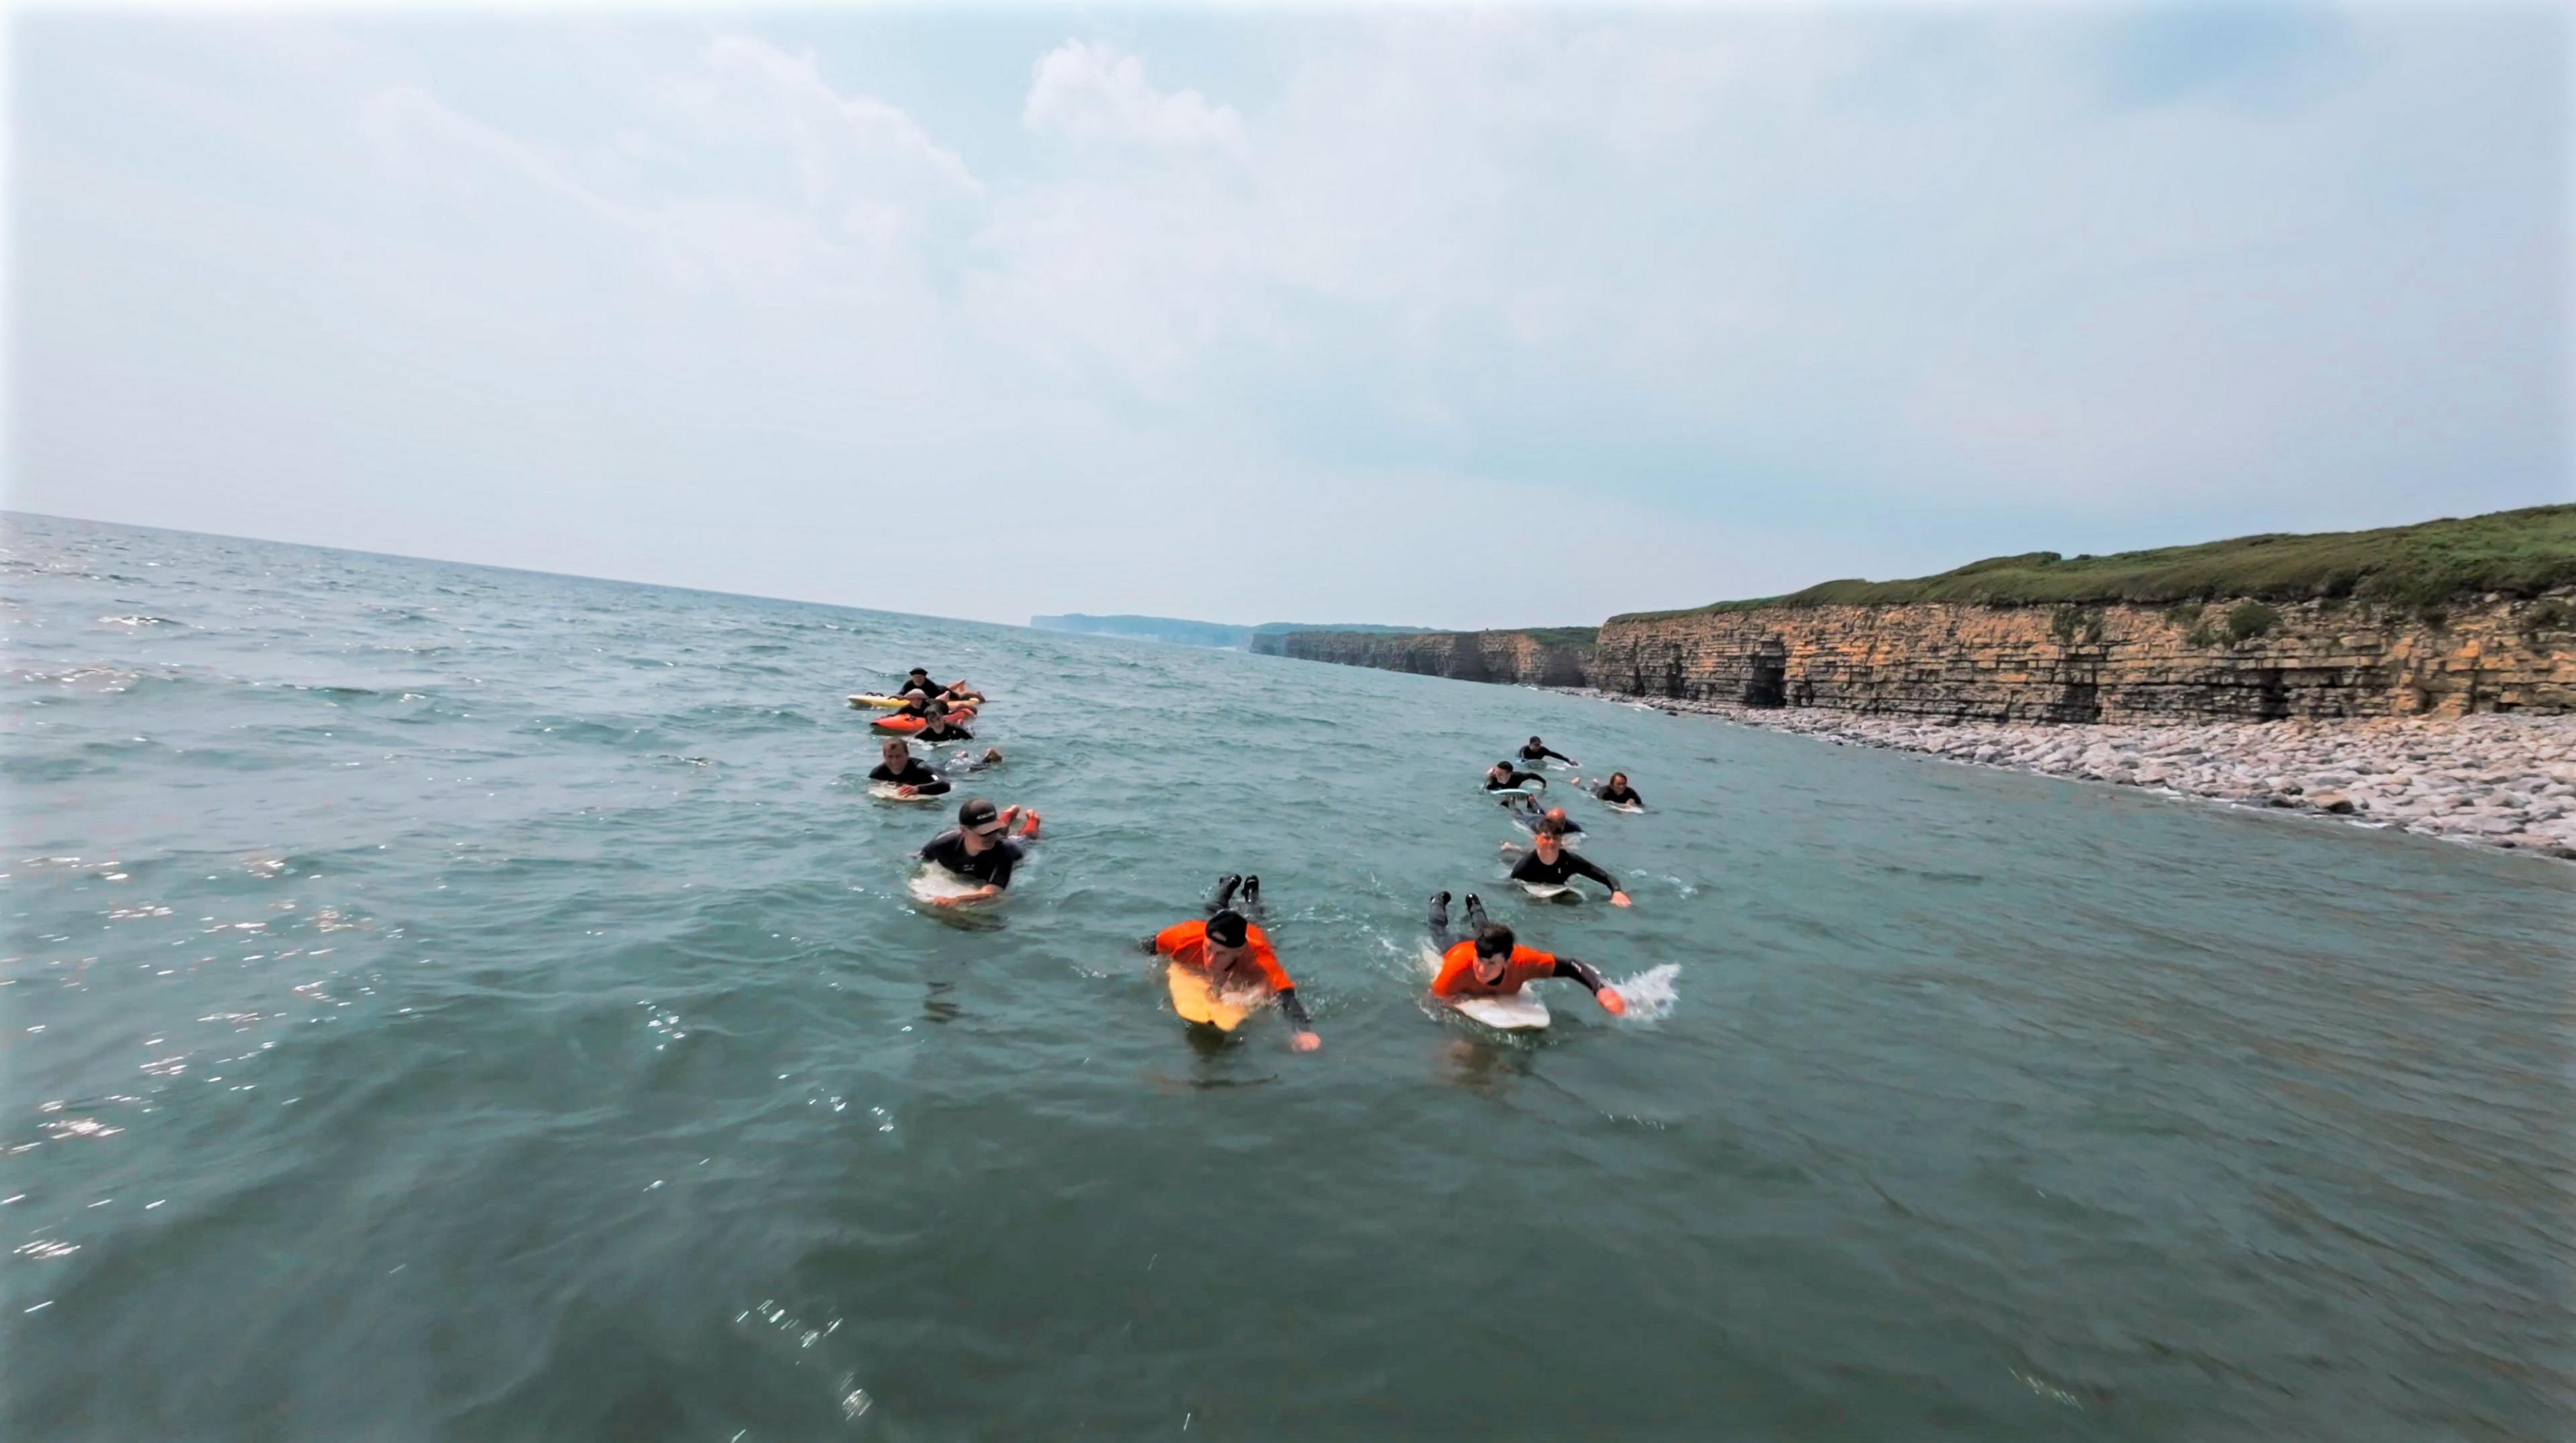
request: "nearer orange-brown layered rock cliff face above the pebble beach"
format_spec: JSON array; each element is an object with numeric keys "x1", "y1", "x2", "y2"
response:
[{"x1": 1597, "y1": 588, "x2": 2576, "y2": 722}]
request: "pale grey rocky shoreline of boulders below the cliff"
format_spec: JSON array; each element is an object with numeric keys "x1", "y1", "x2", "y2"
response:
[{"x1": 1556, "y1": 688, "x2": 2576, "y2": 861}]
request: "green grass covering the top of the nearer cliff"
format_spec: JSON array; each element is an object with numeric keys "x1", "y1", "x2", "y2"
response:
[{"x1": 1613, "y1": 505, "x2": 2576, "y2": 621}]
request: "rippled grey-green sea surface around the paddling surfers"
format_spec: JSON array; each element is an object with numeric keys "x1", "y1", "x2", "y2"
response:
[{"x1": 0, "y1": 518, "x2": 2576, "y2": 1443}]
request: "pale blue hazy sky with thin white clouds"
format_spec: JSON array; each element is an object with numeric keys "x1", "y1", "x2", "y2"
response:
[{"x1": 0, "y1": 0, "x2": 2576, "y2": 626}]
